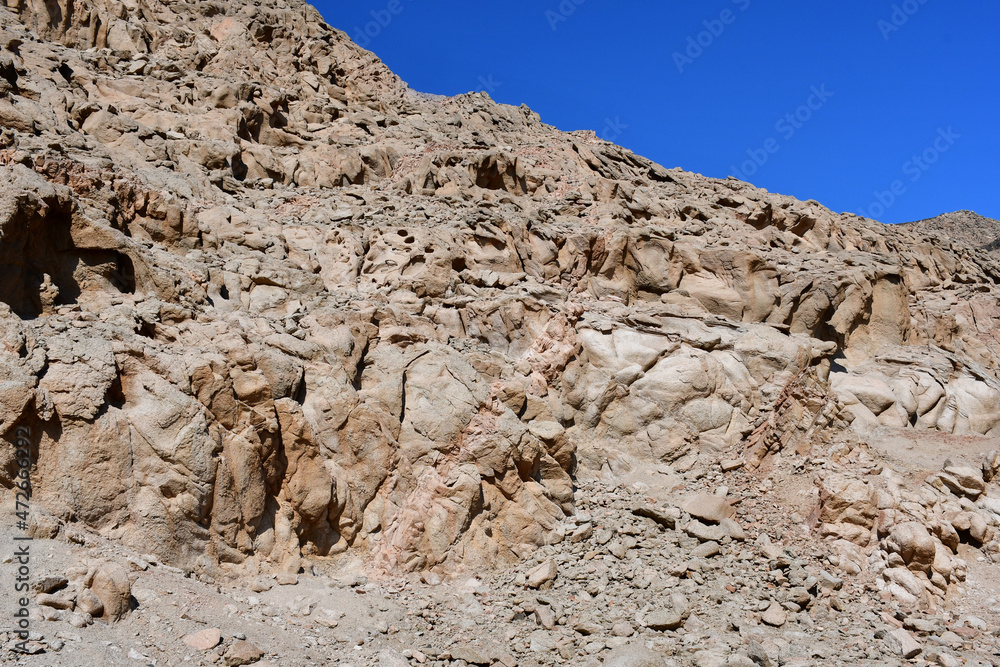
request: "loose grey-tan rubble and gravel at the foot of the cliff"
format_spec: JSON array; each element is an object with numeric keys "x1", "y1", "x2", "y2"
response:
[{"x1": 9, "y1": 448, "x2": 1000, "y2": 667}]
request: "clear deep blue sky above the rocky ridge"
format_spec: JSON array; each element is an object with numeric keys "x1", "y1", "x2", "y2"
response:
[{"x1": 316, "y1": 0, "x2": 1000, "y2": 222}]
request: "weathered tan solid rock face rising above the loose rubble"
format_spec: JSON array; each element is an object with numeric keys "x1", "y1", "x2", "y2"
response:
[{"x1": 0, "y1": 0, "x2": 1000, "y2": 588}]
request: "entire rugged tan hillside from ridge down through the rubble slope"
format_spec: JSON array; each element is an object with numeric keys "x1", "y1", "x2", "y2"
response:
[{"x1": 0, "y1": 0, "x2": 1000, "y2": 666}]
